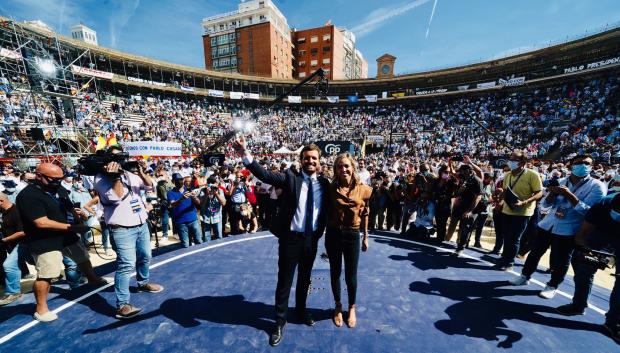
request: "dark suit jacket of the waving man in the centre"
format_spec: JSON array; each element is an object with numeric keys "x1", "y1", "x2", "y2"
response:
[{"x1": 246, "y1": 160, "x2": 329, "y2": 240}]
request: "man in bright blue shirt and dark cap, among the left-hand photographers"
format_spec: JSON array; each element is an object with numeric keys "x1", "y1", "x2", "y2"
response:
[{"x1": 168, "y1": 173, "x2": 203, "y2": 248}]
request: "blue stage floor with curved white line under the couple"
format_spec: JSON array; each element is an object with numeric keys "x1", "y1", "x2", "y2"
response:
[{"x1": 0, "y1": 233, "x2": 620, "y2": 353}]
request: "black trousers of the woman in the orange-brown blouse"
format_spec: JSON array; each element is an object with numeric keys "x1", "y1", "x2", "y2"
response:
[{"x1": 325, "y1": 228, "x2": 361, "y2": 305}]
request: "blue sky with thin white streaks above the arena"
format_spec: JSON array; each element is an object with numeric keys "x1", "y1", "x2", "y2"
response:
[{"x1": 0, "y1": 0, "x2": 620, "y2": 77}]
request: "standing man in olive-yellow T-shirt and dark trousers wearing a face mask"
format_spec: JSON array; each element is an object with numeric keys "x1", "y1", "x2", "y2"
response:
[{"x1": 495, "y1": 151, "x2": 543, "y2": 271}]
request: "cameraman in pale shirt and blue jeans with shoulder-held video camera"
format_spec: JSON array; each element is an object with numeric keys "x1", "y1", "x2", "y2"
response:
[{"x1": 95, "y1": 145, "x2": 164, "y2": 319}]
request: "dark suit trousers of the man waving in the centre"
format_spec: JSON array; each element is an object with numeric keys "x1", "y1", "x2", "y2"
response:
[{"x1": 275, "y1": 234, "x2": 318, "y2": 325}]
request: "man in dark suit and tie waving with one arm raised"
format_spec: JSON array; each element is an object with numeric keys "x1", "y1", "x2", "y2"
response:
[{"x1": 233, "y1": 137, "x2": 329, "y2": 346}]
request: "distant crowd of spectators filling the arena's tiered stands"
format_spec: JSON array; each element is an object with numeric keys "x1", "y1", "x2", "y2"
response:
[{"x1": 0, "y1": 75, "x2": 620, "y2": 161}]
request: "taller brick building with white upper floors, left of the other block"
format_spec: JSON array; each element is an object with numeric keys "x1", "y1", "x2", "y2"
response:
[{"x1": 202, "y1": 0, "x2": 293, "y2": 79}]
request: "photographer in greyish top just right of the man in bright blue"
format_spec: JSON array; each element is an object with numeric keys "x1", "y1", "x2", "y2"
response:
[{"x1": 199, "y1": 176, "x2": 226, "y2": 241}]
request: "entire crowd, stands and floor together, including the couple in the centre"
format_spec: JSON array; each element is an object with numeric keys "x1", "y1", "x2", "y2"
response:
[{"x1": 0, "y1": 71, "x2": 620, "y2": 345}]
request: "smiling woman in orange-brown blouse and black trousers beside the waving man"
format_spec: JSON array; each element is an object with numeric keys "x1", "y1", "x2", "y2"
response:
[{"x1": 325, "y1": 153, "x2": 372, "y2": 328}]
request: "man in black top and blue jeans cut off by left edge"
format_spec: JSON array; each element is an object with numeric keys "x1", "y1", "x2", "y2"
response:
[{"x1": 0, "y1": 193, "x2": 27, "y2": 306}]
